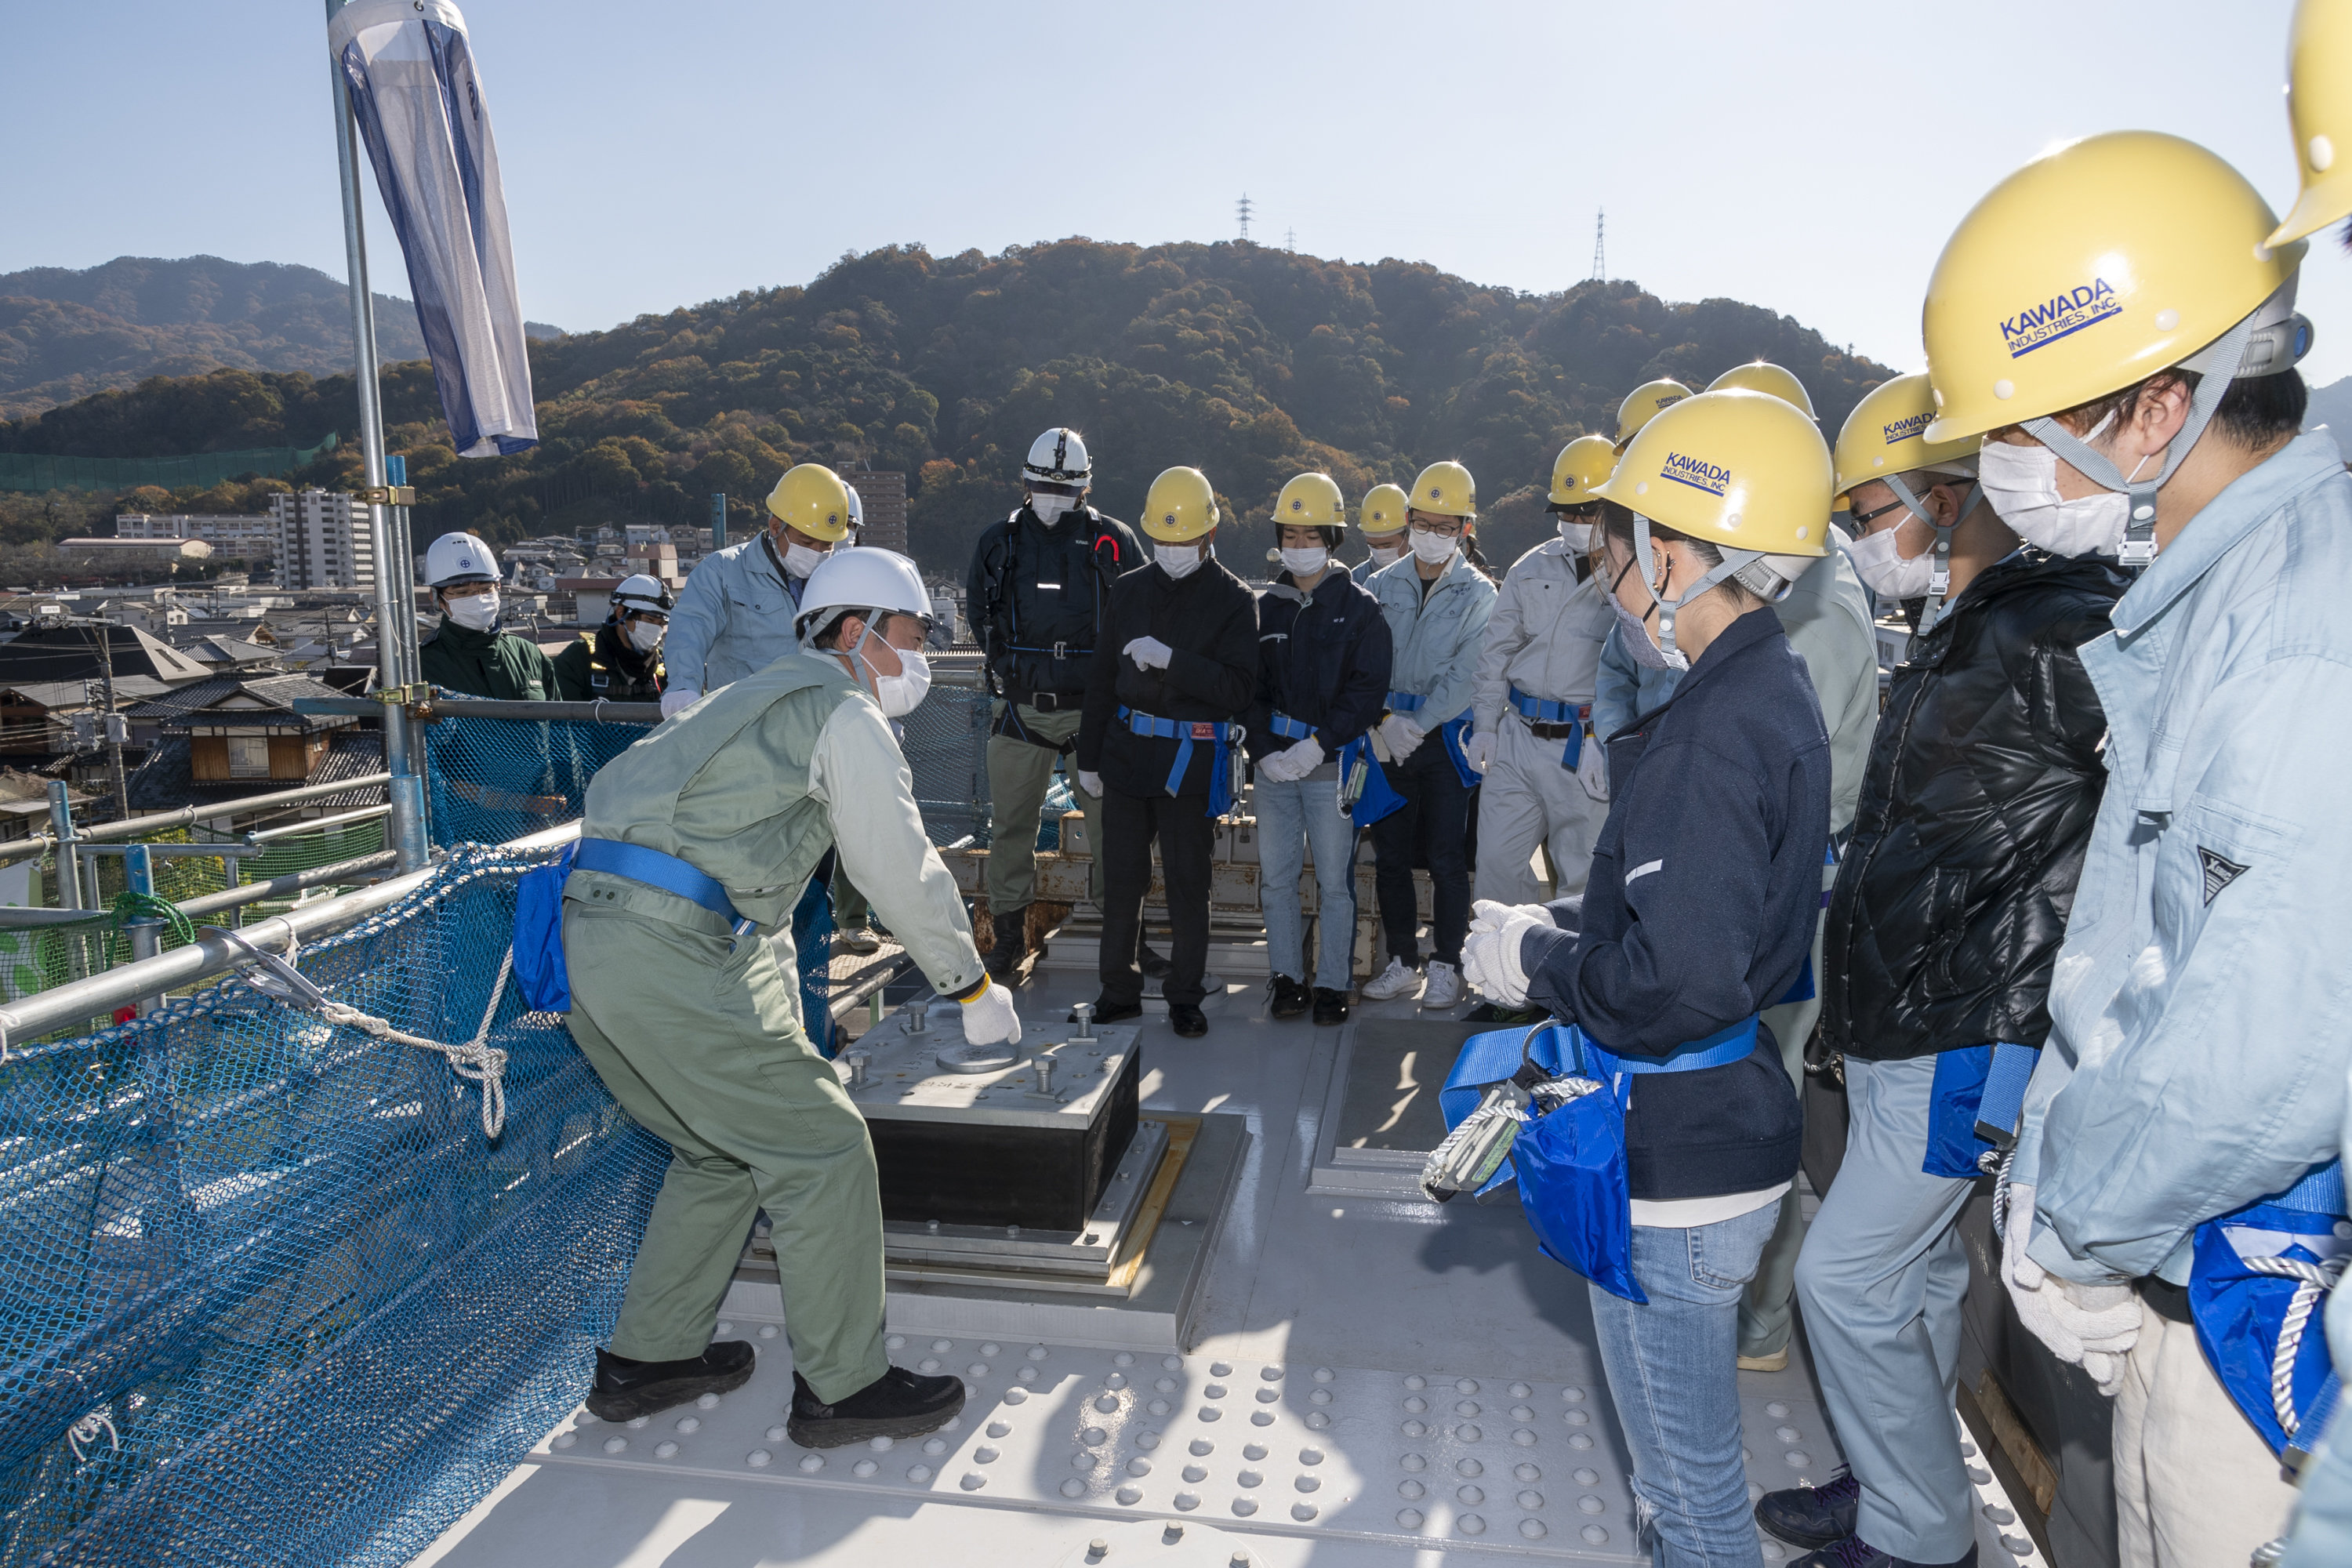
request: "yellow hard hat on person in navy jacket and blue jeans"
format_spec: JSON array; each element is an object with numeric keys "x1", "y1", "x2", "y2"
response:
[{"x1": 1595, "y1": 390, "x2": 1830, "y2": 555}]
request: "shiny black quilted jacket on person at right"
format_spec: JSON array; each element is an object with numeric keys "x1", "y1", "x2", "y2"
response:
[{"x1": 1820, "y1": 550, "x2": 2131, "y2": 1060}]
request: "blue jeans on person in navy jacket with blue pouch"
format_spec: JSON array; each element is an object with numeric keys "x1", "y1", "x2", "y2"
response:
[{"x1": 1590, "y1": 1203, "x2": 1780, "y2": 1568}]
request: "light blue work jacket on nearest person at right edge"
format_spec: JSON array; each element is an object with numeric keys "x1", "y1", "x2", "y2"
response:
[{"x1": 2013, "y1": 430, "x2": 2352, "y2": 1283}]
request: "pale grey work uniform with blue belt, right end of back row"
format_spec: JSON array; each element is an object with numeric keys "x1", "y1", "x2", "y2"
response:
[{"x1": 1470, "y1": 539, "x2": 1616, "y2": 902}]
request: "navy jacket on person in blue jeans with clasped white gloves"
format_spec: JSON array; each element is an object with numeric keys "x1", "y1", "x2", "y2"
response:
[{"x1": 1519, "y1": 609, "x2": 1830, "y2": 1199}]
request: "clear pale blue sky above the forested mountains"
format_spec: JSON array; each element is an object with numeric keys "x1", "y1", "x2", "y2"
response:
[{"x1": 0, "y1": 0, "x2": 2352, "y2": 383}]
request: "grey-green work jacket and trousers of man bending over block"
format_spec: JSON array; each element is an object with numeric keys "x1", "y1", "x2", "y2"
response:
[{"x1": 564, "y1": 654, "x2": 981, "y2": 1401}]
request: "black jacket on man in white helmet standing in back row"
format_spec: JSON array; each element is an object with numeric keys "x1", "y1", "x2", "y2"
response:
[{"x1": 964, "y1": 506, "x2": 1150, "y2": 708}]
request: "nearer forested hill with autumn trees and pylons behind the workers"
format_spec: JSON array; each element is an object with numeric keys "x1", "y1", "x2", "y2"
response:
[{"x1": 0, "y1": 240, "x2": 1891, "y2": 576}]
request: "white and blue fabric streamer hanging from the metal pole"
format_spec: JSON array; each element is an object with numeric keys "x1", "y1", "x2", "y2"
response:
[{"x1": 327, "y1": 0, "x2": 539, "y2": 459}]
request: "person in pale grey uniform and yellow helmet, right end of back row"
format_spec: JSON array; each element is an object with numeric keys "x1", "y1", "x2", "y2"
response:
[{"x1": 1463, "y1": 435, "x2": 1616, "y2": 902}]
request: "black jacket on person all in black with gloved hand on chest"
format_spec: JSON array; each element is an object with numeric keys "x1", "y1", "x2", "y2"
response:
[{"x1": 1077, "y1": 560, "x2": 1258, "y2": 794}]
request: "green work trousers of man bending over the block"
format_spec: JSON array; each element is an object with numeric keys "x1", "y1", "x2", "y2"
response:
[{"x1": 564, "y1": 900, "x2": 889, "y2": 1401}]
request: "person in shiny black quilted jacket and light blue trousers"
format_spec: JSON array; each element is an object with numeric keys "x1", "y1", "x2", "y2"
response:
[{"x1": 1757, "y1": 376, "x2": 2126, "y2": 1563}]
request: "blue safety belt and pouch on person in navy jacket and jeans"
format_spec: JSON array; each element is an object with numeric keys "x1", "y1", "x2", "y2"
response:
[{"x1": 1437, "y1": 1013, "x2": 1757, "y2": 1302}]
